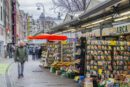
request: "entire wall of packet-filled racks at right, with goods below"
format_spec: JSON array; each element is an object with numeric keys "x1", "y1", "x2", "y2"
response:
[{"x1": 86, "y1": 40, "x2": 130, "y2": 87}]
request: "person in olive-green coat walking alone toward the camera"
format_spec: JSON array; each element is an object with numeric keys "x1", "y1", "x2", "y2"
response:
[{"x1": 15, "y1": 41, "x2": 28, "y2": 78}]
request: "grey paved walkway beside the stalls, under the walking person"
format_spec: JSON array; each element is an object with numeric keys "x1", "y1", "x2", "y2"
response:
[{"x1": 9, "y1": 60, "x2": 77, "y2": 87}]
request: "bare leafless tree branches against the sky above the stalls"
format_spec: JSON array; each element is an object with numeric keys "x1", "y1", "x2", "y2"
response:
[{"x1": 52, "y1": 0, "x2": 91, "y2": 12}]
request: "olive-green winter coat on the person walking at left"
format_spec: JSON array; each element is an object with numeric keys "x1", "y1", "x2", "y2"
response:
[{"x1": 15, "y1": 47, "x2": 28, "y2": 63}]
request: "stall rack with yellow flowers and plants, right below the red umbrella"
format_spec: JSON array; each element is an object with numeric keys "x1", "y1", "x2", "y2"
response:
[{"x1": 51, "y1": 39, "x2": 80, "y2": 78}]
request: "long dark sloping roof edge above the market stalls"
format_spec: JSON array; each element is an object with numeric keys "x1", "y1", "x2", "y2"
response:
[{"x1": 33, "y1": 0, "x2": 122, "y2": 33}]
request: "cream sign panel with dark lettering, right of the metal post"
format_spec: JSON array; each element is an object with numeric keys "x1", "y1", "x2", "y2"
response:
[{"x1": 102, "y1": 24, "x2": 130, "y2": 41}]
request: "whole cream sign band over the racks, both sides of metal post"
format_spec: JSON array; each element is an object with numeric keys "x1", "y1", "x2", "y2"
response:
[{"x1": 85, "y1": 24, "x2": 130, "y2": 41}]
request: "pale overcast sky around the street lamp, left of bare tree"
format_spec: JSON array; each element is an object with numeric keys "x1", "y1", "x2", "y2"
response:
[{"x1": 18, "y1": 0, "x2": 57, "y2": 19}]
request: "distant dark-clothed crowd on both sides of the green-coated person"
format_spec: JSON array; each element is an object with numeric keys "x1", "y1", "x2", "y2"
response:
[{"x1": 4, "y1": 43, "x2": 42, "y2": 60}]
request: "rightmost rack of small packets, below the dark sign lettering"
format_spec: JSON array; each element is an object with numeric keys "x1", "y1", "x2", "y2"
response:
[{"x1": 113, "y1": 41, "x2": 130, "y2": 74}]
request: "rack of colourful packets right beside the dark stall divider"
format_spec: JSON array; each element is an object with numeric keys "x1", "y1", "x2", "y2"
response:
[{"x1": 86, "y1": 41, "x2": 112, "y2": 77}]
